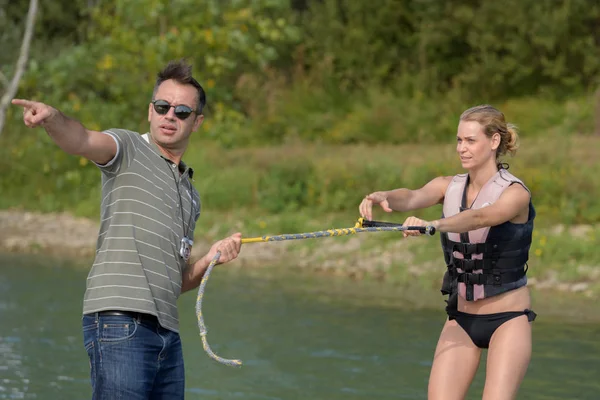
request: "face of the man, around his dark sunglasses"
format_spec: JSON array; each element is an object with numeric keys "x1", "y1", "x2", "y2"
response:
[{"x1": 148, "y1": 79, "x2": 204, "y2": 152}]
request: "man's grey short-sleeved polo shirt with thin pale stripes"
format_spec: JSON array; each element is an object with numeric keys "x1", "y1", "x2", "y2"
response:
[{"x1": 83, "y1": 129, "x2": 200, "y2": 332}]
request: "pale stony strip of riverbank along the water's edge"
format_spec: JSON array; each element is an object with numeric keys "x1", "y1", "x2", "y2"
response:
[{"x1": 0, "y1": 210, "x2": 600, "y2": 320}]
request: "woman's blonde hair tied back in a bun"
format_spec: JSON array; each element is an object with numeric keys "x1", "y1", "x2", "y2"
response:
[{"x1": 460, "y1": 104, "x2": 519, "y2": 159}]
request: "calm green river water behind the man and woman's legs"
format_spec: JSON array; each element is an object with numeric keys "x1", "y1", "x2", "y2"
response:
[{"x1": 0, "y1": 254, "x2": 600, "y2": 400}]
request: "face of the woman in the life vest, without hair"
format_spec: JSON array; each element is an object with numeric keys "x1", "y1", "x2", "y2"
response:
[{"x1": 456, "y1": 121, "x2": 500, "y2": 169}]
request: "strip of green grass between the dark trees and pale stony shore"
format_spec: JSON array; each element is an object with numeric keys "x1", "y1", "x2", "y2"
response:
[{"x1": 0, "y1": 130, "x2": 600, "y2": 225}]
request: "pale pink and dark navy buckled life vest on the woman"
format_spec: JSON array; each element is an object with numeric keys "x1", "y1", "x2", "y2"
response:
[{"x1": 440, "y1": 168, "x2": 535, "y2": 301}]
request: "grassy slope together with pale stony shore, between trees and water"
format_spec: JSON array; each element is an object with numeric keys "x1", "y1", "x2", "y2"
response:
[{"x1": 0, "y1": 132, "x2": 600, "y2": 298}]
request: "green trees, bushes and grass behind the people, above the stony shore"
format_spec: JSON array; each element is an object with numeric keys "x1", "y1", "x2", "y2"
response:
[{"x1": 0, "y1": 0, "x2": 600, "y2": 227}]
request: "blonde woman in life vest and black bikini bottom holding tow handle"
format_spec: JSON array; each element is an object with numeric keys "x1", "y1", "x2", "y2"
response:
[{"x1": 359, "y1": 105, "x2": 535, "y2": 400}]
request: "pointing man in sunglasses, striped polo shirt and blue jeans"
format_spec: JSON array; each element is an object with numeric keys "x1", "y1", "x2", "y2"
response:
[{"x1": 12, "y1": 61, "x2": 241, "y2": 400}]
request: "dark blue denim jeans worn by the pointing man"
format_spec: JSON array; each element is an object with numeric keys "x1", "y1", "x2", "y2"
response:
[{"x1": 83, "y1": 313, "x2": 185, "y2": 400}]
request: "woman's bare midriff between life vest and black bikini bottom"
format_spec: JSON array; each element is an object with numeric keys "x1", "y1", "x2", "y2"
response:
[{"x1": 458, "y1": 286, "x2": 531, "y2": 314}]
